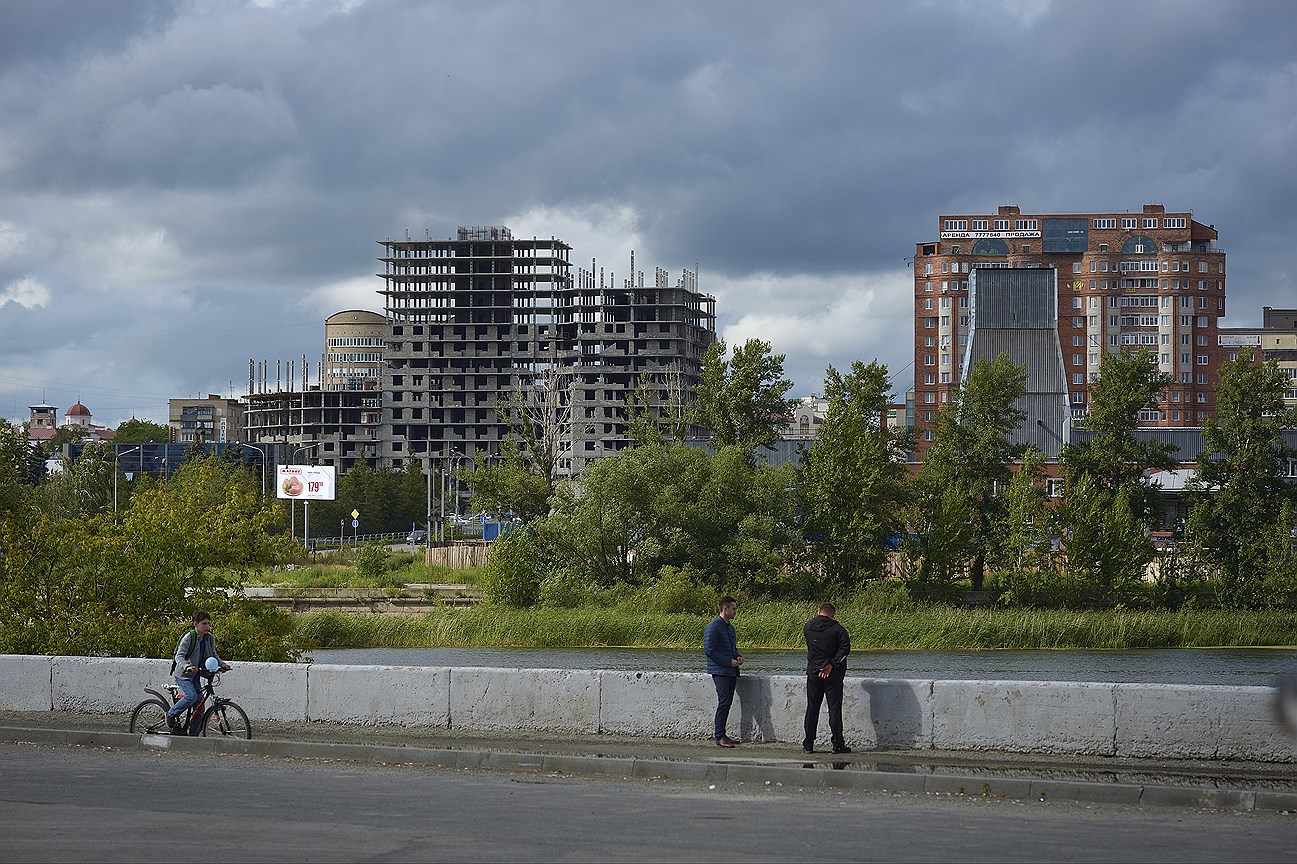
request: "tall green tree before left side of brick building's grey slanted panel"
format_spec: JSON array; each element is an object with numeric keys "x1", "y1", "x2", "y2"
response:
[{"x1": 918, "y1": 354, "x2": 1027, "y2": 590}]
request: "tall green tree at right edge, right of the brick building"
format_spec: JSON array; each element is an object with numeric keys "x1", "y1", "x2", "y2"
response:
[{"x1": 1187, "y1": 357, "x2": 1297, "y2": 606}]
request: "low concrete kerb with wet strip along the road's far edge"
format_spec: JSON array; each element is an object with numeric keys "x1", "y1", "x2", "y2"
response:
[{"x1": 0, "y1": 728, "x2": 1297, "y2": 813}]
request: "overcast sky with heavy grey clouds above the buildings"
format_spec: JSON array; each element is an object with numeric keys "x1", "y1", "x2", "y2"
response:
[{"x1": 0, "y1": 0, "x2": 1297, "y2": 426}]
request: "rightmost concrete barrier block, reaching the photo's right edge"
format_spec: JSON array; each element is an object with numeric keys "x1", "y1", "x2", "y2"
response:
[{"x1": 1117, "y1": 684, "x2": 1297, "y2": 762}]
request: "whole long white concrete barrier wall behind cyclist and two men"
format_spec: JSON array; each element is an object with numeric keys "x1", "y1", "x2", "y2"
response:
[{"x1": 0, "y1": 655, "x2": 1297, "y2": 763}]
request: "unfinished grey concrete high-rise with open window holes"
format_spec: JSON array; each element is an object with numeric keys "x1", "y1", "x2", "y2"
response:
[{"x1": 379, "y1": 226, "x2": 716, "y2": 475}]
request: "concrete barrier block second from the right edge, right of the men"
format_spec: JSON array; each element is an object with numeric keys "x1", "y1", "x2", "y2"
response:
[{"x1": 933, "y1": 681, "x2": 1117, "y2": 755}]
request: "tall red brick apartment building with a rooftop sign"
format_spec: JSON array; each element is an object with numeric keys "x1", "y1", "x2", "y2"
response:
[{"x1": 913, "y1": 204, "x2": 1226, "y2": 461}]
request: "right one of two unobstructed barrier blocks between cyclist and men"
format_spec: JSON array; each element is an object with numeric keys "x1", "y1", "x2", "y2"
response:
[{"x1": 450, "y1": 668, "x2": 599, "y2": 733}]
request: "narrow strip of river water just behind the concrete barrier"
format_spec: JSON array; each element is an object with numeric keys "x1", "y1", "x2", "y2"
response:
[{"x1": 307, "y1": 646, "x2": 1297, "y2": 686}]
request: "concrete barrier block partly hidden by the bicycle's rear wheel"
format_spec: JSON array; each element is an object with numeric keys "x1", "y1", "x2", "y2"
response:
[{"x1": 51, "y1": 656, "x2": 171, "y2": 710}]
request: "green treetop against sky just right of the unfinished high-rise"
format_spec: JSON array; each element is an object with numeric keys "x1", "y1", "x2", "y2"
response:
[{"x1": 694, "y1": 339, "x2": 792, "y2": 455}]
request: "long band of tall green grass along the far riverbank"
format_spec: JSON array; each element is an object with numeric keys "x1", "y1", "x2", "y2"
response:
[{"x1": 296, "y1": 602, "x2": 1297, "y2": 651}]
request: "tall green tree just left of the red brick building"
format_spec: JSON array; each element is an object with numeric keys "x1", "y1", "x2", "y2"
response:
[{"x1": 800, "y1": 361, "x2": 910, "y2": 585}]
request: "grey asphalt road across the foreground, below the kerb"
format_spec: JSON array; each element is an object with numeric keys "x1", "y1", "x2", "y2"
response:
[{"x1": 0, "y1": 743, "x2": 1297, "y2": 861}]
